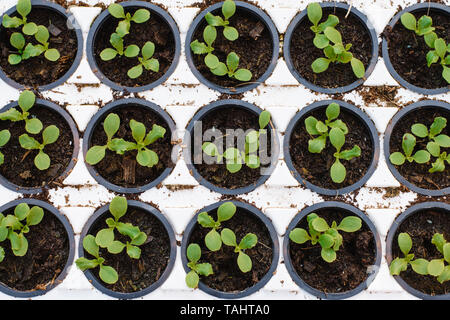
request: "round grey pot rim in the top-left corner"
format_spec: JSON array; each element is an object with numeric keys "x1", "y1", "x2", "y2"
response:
[{"x1": 0, "y1": 0, "x2": 84, "y2": 92}]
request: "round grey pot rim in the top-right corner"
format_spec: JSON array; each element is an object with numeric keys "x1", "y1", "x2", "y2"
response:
[{"x1": 381, "y1": 2, "x2": 450, "y2": 95}]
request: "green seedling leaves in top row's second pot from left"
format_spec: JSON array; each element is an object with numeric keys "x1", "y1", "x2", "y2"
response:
[{"x1": 100, "y1": 3, "x2": 159, "y2": 79}]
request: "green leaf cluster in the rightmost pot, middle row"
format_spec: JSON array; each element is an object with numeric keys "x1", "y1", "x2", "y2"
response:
[{"x1": 389, "y1": 117, "x2": 450, "y2": 173}]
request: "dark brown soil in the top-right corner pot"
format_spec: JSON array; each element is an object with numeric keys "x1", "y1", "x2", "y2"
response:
[{"x1": 383, "y1": 9, "x2": 450, "y2": 89}]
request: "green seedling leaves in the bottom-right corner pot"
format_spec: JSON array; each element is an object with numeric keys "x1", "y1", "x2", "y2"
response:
[{"x1": 389, "y1": 233, "x2": 450, "y2": 284}]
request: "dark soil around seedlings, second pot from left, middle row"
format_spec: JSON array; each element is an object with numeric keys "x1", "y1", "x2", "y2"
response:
[{"x1": 89, "y1": 105, "x2": 174, "y2": 188}]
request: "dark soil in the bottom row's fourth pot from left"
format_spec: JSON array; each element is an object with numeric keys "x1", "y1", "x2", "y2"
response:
[{"x1": 289, "y1": 209, "x2": 376, "y2": 293}]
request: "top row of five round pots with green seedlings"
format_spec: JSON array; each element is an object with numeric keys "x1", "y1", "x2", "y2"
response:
[{"x1": 0, "y1": 0, "x2": 450, "y2": 94}]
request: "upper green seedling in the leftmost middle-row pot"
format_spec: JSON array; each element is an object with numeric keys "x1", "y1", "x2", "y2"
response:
[{"x1": 0, "y1": 90, "x2": 43, "y2": 134}]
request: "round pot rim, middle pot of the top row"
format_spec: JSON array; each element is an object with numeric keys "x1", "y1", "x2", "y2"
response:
[{"x1": 185, "y1": 0, "x2": 280, "y2": 95}]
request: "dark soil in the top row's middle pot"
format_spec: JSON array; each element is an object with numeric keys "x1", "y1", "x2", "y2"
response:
[{"x1": 192, "y1": 8, "x2": 273, "y2": 87}]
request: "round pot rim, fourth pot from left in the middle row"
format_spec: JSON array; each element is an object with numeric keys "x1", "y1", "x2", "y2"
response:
[{"x1": 283, "y1": 100, "x2": 380, "y2": 196}]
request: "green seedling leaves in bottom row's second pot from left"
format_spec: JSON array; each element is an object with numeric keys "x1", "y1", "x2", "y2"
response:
[{"x1": 76, "y1": 197, "x2": 147, "y2": 284}]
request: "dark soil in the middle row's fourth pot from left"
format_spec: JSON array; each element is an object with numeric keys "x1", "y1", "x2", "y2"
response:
[{"x1": 289, "y1": 106, "x2": 374, "y2": 189}]
